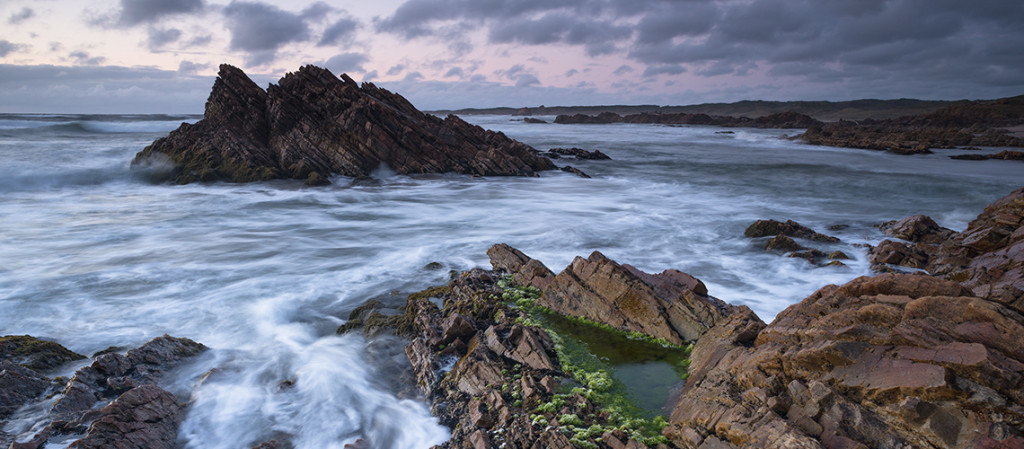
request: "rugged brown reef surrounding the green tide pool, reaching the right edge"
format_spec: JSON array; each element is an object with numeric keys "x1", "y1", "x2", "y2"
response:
[{"x1": 350, "y1": 185, "x2": 1024, "y2": 449}]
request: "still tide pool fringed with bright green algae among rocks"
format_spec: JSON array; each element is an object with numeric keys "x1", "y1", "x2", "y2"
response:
[{"x1": 494, "y1": 276, "x2": 692, "y2": 448}]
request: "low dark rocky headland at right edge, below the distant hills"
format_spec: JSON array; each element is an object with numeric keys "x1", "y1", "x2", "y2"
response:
[{"x1": 796, "y1": 95, "x2": 1024, "y2": 152}]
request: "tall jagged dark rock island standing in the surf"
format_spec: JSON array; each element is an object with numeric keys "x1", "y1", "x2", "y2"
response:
[{"x1": 132, "y1": 65, "x2": 555, "y2": 185}]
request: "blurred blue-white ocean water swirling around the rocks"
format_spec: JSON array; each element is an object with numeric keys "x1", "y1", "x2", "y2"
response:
[{"x1": 0, "y1": 114, "x2": 1024, "y2": 449}]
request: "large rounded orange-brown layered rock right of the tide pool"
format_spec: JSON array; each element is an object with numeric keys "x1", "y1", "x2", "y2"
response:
[{"x1": 666, "y1": 274, "x2": 1024, "y2": 448}]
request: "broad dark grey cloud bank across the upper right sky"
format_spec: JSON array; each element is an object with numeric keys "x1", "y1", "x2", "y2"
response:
[{"x1": 375, "y1": 0, "x2": 1024, "y2": 97}]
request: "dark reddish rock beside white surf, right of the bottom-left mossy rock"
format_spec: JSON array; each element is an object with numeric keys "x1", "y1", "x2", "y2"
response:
[{"x1": 10, "y1": 335, "x2": 206, "y2": 449}]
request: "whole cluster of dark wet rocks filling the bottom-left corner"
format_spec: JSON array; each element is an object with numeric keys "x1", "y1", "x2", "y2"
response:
[{"x1": 0, "y1": 335, "x2": 206, "y2": 449}]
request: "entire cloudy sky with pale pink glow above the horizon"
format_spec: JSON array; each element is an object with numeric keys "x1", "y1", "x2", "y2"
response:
[{"x1": 0, "y1": 0, "x2": 1024, "y2": 113}]
